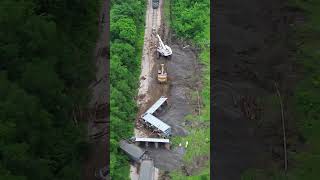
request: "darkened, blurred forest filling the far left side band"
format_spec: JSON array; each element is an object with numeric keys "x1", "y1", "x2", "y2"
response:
[{"x1": 0, "y1": 0, "x2": 99, "y2": 180}]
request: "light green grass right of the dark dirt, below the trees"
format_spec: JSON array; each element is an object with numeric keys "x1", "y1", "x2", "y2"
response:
[{"x1": 170, "y1": 41, "x2": 210, "y2": 180}]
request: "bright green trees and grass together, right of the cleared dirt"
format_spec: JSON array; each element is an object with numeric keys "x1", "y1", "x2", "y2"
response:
[{"x1": 164, "y1": 0, "x2": 210, "y2": 180}]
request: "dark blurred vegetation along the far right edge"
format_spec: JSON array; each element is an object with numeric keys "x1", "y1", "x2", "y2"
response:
[{"x1": 243, "y1": 0, "x2": 320, "y2": 180}]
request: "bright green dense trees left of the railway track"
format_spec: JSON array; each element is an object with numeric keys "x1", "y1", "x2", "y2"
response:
[{"x1": 110, "y1": 0, "x2": 146, "y2": 179}]
